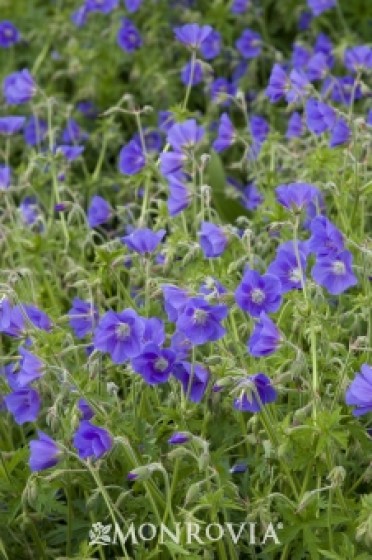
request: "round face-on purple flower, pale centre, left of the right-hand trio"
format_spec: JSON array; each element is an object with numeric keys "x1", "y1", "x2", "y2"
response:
[{"x1": 235, "y1": 268, "x2": 282, "y2": 317}]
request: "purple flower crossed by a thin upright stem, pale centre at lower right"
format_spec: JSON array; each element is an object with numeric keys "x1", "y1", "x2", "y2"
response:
[{"x1": 267, "y1": 241, "x2": 307, "y2": 294}]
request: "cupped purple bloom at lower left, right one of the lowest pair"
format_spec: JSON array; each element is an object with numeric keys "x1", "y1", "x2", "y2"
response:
[{"x1": 73, "y1": 420, "x2": 113, "y2": 459}]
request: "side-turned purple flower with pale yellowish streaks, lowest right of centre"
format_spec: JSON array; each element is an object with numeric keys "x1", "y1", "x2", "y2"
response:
[{"x1": 234, "y1": 373, "x2": 277, "y2": 412}]
